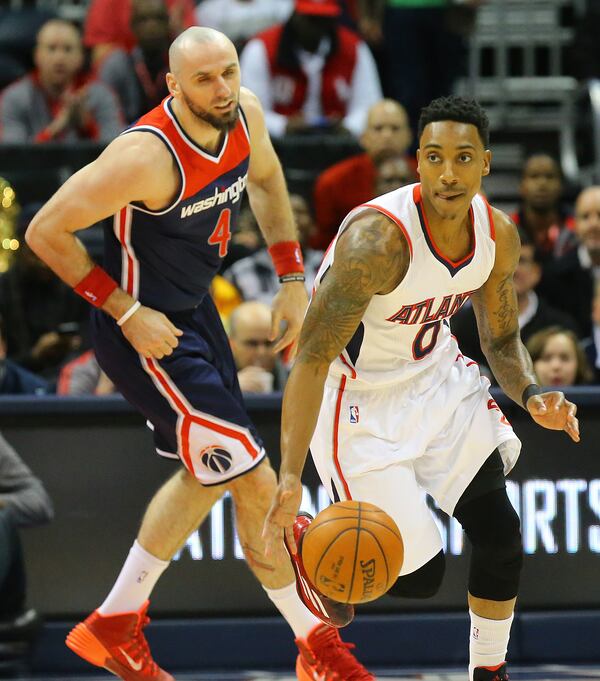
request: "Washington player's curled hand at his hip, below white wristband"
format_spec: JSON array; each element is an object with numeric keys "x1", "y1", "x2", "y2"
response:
[{"x1": 121, "y1": 305, "x2": 183, "y2": 359}]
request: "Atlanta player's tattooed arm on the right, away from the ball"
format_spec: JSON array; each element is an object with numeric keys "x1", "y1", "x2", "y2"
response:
[{"x1": 472, "y1": 209, "x2": 579, "y2": 442}]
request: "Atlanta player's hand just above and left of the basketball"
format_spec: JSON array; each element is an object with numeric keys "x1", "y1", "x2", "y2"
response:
[{"x1": 262, "y1": 475, "x2": 302, "y2": 557}]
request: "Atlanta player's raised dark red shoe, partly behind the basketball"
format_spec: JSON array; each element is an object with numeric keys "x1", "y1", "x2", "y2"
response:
[{"x1": 284, "y1": 511, "x2": 354, "y2": 628}]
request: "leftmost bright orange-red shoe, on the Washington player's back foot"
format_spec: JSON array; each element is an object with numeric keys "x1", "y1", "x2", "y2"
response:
[{"x1": 67, "y1": 601, "x2": 175, "y2": 681}]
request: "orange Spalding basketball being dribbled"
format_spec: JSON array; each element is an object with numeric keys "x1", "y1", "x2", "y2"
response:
[{"x1": 300, "y1": 501, "x2": 404, "y2": 603}]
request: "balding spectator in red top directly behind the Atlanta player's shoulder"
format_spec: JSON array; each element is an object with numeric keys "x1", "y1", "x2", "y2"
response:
[{"x1": 311, "y1": 99, "x2": 416, "y2": 250}]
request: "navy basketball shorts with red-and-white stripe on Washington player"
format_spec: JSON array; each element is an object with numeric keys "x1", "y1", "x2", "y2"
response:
[{"x1": 91, "y1": 295, "x2": 265, "y2": 485}]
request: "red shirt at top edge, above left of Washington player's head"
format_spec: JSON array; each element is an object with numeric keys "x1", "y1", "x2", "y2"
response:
[{"x1": 83, "y1": 0, "x2": 196, "y2": 50}]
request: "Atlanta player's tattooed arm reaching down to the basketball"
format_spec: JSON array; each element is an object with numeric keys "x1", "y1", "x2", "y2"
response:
[{"x1": 264, "y1": 211, "x2": 409, "y2": 552}]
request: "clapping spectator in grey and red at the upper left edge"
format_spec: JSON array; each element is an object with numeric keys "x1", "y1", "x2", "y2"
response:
[{"x1": 0, "y1": 19, "x2": 124, "y2": 143}]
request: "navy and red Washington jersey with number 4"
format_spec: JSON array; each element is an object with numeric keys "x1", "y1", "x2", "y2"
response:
[{"x1": 104, "y1": 97, "x2": 250, "y2": 312}]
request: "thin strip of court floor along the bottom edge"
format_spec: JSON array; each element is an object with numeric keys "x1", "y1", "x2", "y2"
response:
[{"x1": 12, "y1": 665, "x2": 600, "y2": 681}]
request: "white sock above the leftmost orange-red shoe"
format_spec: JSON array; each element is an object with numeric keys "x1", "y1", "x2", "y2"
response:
[{"x1": 98, "y1": 540, "x2": 169, "y2": 615}]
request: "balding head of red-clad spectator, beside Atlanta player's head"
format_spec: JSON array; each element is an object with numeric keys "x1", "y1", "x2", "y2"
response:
[{"x1": 360, "y1": 99, "x2": 412, "y2": 162}]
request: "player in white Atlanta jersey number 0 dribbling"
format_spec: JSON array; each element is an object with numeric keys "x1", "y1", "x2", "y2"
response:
[{"x1": 265, "y1": 97, "x2": 579, "y2": 681}]
